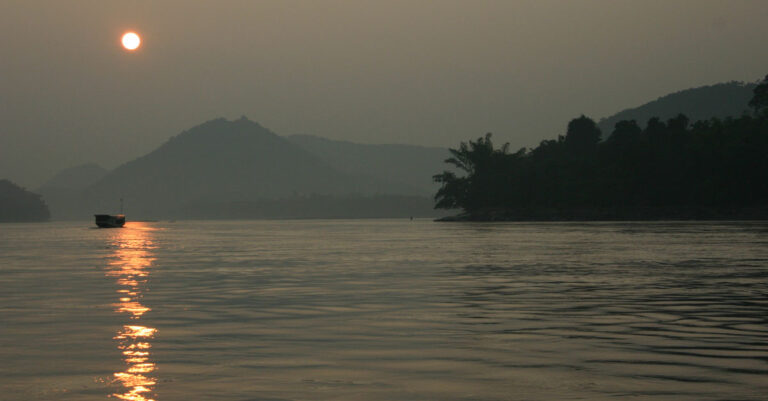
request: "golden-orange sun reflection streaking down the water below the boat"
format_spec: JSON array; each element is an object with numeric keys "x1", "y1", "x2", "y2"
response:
[{"x1": 106, "y1": 222, "x2": 157, "y2": 401}]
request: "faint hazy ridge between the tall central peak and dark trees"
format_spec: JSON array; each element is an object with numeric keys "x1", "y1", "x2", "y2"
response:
[{"x1": 286, "y1": 135, "x2": 448, "y2": 195}]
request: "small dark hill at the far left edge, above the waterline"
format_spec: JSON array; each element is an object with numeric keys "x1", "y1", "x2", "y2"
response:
[{"x1": 0, "y1": 180, "x2": 50, "y2": 222}]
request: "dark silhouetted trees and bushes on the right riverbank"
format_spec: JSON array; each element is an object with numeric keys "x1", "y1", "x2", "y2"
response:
[{"x1": 434, "y1": 77, "x2": 768, "y2": 219}]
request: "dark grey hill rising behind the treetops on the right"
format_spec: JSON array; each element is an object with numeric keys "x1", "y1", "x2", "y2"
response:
[{"x1": 597, "y1": 81, "x2": 757, "y2": 138}]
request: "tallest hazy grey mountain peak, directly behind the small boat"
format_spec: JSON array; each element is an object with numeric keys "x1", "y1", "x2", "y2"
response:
[{"x1": 59, "y1": 117, "x2": 428, "y2": 218}]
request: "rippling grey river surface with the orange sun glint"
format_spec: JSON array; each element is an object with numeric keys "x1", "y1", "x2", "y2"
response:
[{"x1": 0, "y1": 220, "x2": 768, "y2": 401}]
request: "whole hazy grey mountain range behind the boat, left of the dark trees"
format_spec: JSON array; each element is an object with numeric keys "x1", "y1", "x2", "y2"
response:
[{"x1": 40, "y1": 118, "x2": 447, "y2": 218}]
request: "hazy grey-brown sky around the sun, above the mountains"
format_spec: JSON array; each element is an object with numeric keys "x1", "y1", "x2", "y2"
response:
[{"x1": 0, "y1": 0, "x2": 768, "y2": 187}]
